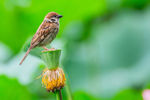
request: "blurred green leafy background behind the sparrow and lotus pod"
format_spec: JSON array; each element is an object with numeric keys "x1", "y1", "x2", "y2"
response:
[{"x1": 0, "y1": 0, "x2": 150, "y2": 100}]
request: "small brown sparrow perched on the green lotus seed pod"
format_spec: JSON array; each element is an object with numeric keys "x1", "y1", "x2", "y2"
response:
[{"x1": 19, "y1": 12, "x2": 62, "y2": 65}]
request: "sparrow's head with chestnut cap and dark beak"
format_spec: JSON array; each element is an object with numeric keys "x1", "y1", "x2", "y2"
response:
[{"x1": 45, "y1": 12, "x2": 62, "y2": 23}]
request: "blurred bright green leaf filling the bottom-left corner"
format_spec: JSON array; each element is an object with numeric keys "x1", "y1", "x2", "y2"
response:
[{"x1": 0, "y1": 75, "x2": 33, "y2": 100}]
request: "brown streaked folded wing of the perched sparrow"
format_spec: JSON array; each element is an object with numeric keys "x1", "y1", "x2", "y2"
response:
[{"x1": 31, "y1": 22, "x2": 51, "y2": 48}]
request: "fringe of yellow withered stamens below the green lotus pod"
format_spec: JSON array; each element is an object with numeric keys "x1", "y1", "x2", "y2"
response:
[{"x1": 42, "y1": 67, "x2": 66, "y2": 92}]
